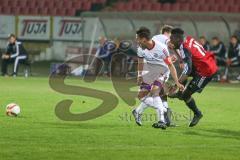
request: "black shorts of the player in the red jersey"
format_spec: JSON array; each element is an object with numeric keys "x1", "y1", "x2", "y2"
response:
[{"x1": 187, "y1": 73, "x2": 214, "y2": 94}]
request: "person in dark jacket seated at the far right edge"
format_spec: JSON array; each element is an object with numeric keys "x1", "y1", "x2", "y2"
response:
[{"x1": 225, "y1": 35, "x2": 240, "y2": 80}]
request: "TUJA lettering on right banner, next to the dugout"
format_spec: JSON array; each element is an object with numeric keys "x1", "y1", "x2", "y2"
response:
[{"x1": 59, "y1": 20, "x2": 84, "y2": 36}]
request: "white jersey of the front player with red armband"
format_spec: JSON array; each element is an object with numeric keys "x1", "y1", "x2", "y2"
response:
[{"x1": 137, "y1": 41, "x2": 170, "y2": 78}]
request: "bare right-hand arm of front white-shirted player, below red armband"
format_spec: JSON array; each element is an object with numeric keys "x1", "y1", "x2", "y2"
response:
[{"x1": 164, "y1": 57, "x2": 184, "y2": 91}]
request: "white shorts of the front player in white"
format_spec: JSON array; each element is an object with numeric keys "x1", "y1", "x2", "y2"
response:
[{"x1": 142, "y1": 63, "x2": 169, "y2": 85}]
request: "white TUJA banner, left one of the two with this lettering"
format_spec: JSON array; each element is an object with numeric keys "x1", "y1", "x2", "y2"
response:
[{"x1": 18, "y1": 16, "x2": 51, "y2": 40}]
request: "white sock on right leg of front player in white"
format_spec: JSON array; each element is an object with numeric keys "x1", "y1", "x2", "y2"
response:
[{"x1": 153, "y1": 96, "x2": 167, "y2": 123}]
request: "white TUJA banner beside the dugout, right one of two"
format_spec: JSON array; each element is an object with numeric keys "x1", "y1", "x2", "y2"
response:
[{"x1": 53, "y1": 17, "x2": 85, "y2": 41}]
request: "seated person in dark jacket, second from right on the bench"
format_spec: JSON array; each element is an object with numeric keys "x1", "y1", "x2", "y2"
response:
[{"x1": 210, "y1": 37, "x2": 228, "y2": 81}]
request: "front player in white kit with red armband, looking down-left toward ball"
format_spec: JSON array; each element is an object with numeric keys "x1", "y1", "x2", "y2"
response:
[{"x1": 132, "y1": 27, "x2": 184, "y2": 129}]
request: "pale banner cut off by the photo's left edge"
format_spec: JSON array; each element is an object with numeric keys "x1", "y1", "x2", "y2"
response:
[{"x1": 0, "y1": 16, "x2": 15, "y2": 38}]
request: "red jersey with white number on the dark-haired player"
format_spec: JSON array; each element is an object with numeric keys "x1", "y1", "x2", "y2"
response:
[{"x1": 183, "y1": 36, "x2": 218, "y2": 77}]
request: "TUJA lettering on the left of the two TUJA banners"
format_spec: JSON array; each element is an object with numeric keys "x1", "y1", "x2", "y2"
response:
[{"x1": 21, "y1": 19, "x2": 48, "y2": 36}]
